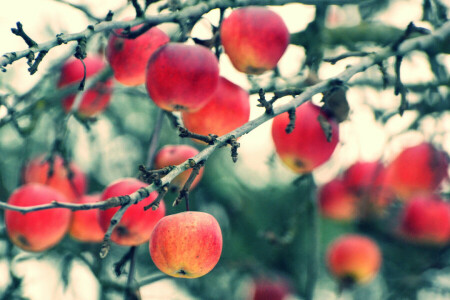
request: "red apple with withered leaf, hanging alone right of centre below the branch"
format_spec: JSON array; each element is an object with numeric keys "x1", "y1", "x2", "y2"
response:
[{"x1": 272, "y1": 101, "x2": 339, "y2": 173}]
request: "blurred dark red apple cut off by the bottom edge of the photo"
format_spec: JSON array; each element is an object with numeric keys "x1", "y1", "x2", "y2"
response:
[{"x1": 248, "y1": 278, "x2": 291, "y2": 300}]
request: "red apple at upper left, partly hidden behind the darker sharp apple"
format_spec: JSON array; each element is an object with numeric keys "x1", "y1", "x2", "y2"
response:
[{"x1": 106, "y1": 26, "x2": 170, "y2": 86}]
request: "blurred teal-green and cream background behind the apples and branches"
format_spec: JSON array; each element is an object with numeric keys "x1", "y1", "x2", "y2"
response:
[{"x1": 0, "y1": 0, "x2": 450, "y2": 300}]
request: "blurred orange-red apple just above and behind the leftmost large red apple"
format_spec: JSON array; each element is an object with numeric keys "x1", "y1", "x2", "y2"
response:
[{"x1": 22, "y1": 155, "x2": 87, "y2": 202}]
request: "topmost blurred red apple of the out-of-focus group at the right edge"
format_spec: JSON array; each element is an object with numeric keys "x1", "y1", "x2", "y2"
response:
[{"x1": 384, "y1": 142, "x2": 449, "y2": 201}]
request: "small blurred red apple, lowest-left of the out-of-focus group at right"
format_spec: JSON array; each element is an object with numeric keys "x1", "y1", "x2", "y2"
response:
[{"x1": 318, "y1": 178, "x2": 359, "y2": 221}]
